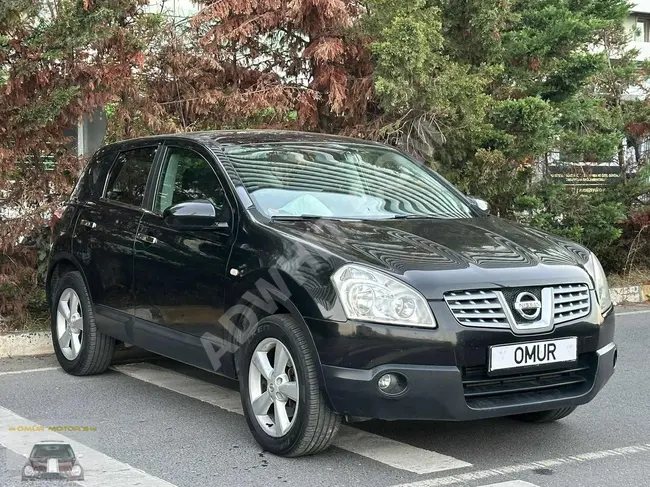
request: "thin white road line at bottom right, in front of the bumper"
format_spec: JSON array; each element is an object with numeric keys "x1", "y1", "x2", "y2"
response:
[{"x1": 393, "y1": 443, "x2": 650, "y2": 487}]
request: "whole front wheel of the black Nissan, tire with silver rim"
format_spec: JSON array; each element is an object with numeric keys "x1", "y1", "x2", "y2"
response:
[{"x1": 238, "y1": 315, "x2": 341, "y2": 457}]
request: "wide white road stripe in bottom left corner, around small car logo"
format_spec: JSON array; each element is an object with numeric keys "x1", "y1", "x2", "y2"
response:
[{"x1": 0, "y1": 407, "x2": 176, "y2": 487}]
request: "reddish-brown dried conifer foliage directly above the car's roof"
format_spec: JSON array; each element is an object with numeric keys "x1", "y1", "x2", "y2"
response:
[{"x1": 170, "y1": 0, "x2": 372, "y2": 131}]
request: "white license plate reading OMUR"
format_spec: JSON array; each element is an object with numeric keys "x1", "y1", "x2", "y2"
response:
[{"x1": 490, "y1": 337, "x2": 578, "y2": 372}]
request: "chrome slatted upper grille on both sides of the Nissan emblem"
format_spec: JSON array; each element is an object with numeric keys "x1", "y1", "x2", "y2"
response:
[{"x1": 443, "y1": 284, "x2": 591, "y2": 333}]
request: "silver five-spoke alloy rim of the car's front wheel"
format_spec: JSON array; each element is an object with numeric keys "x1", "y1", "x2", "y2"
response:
[{"x1": 248, "y1": 338, "x2": 298, "y2": 438}]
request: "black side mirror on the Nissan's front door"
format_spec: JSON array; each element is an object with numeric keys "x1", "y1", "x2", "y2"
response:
[{"x1": 163, "y1": 200, "x2": 230, "y2": 230}]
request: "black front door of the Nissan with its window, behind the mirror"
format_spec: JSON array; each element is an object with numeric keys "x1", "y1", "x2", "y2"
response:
[{"x1": 130, "y1": 145, "x2": 235, "y2": 375}]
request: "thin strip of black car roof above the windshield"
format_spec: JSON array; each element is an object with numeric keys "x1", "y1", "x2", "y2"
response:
[{"x1": 101, "y1": 130, "x2": 383, "y2": 152}]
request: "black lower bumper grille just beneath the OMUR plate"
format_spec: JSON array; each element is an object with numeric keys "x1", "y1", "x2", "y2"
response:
[{"x1": 462, "y1": 354, "x2": 594, "y2": 408}]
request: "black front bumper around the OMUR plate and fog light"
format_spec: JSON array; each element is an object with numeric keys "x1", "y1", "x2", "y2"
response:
[{"x1": 312, "y1": 306, "x2": 617, "y2": 421}]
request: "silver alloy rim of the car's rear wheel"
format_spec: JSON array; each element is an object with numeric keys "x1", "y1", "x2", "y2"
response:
[{"x1": 56, "y1": 288, "x2": 83, "y2": 360}]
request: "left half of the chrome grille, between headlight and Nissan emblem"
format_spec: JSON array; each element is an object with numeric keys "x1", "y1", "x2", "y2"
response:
[{"x1": 445, "y1": 291, "x2": 510, "y2": 328}]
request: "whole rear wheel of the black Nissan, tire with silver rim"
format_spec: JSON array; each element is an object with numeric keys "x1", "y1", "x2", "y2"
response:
[{"x1": 51, "y1": 271, "x2": 115, "y2": 375}]
